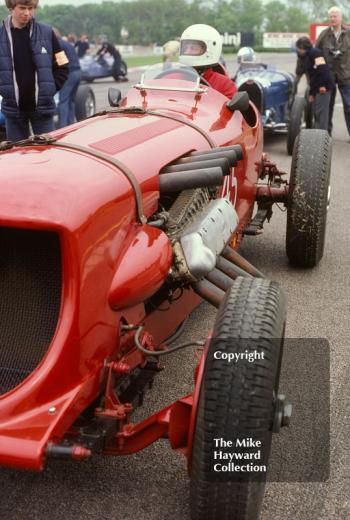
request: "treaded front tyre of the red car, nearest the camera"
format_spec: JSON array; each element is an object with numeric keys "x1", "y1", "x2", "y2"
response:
[{"x1": 191, "y1": 278, "x2": 286, "y2": 520}]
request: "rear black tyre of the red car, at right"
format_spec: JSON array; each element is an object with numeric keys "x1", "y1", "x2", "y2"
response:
[{"x1": 286, "y1": 129, "x2": 332, "y2": 267}]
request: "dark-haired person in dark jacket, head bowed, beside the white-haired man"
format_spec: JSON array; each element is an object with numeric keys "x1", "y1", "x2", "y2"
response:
[{"x1": 296, "y1": 36, "x2": 335, "y2": 130}]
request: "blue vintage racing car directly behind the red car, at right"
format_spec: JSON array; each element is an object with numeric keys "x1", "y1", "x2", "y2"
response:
[{"x1": 235, "y1": 63, "x2": 312, "y2": 155}]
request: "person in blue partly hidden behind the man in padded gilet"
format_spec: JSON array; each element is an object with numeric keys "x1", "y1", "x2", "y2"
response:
[{"x1": 55, "y1": 30, "x2": 81, "y2": 128}]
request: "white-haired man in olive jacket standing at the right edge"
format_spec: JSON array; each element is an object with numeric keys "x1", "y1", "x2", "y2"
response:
[{"x1": 316, "y1": 6, "x2": 350, "y2": 135}]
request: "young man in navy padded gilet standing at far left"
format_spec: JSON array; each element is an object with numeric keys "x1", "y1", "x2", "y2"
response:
[{"x1": 0, "y1": 0, "x2": 68, "y2": 141}]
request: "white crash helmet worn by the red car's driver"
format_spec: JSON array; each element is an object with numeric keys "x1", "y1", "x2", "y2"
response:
[{"x1": 179, "y1": 23, "x2": 222, "y2": 67}]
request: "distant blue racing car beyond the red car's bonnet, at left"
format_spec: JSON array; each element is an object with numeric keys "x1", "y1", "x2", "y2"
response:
[{"x1": 79, "y1": 54, "x2": 128, "y2": 83}]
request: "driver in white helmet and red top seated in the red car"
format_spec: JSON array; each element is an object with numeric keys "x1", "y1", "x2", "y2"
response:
[{"x1": 179, "y1": 24, "x2": 237, "y2": 99}]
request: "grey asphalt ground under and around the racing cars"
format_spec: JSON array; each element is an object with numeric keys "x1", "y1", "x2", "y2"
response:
[{"x1": 0, "y1": 54, "x2": 350, "y2": 520}]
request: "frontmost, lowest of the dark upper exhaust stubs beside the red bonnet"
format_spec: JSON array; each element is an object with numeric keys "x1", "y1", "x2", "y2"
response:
[{"x1": 159, "y1": 167, "x2": 223, "y2": 193}]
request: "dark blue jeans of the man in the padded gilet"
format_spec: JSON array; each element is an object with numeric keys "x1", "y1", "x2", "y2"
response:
[{"x1": 6, "y1": 112, "x2": 55, "y2": 141}]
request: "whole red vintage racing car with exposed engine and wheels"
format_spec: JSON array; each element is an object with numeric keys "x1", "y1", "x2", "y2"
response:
[{"x1": 0, "y1": 64, "x2": 331, "y2": 520}]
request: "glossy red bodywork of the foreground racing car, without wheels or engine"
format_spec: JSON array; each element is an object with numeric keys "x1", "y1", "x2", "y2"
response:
[{"x1": 0, "y1": 76, "x2": 262, "y2": 470}]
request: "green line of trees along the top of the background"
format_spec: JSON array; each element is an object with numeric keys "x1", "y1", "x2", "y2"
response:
[{"x1": 0, "y1": 0, "x2": 349, "y2": 45}]
